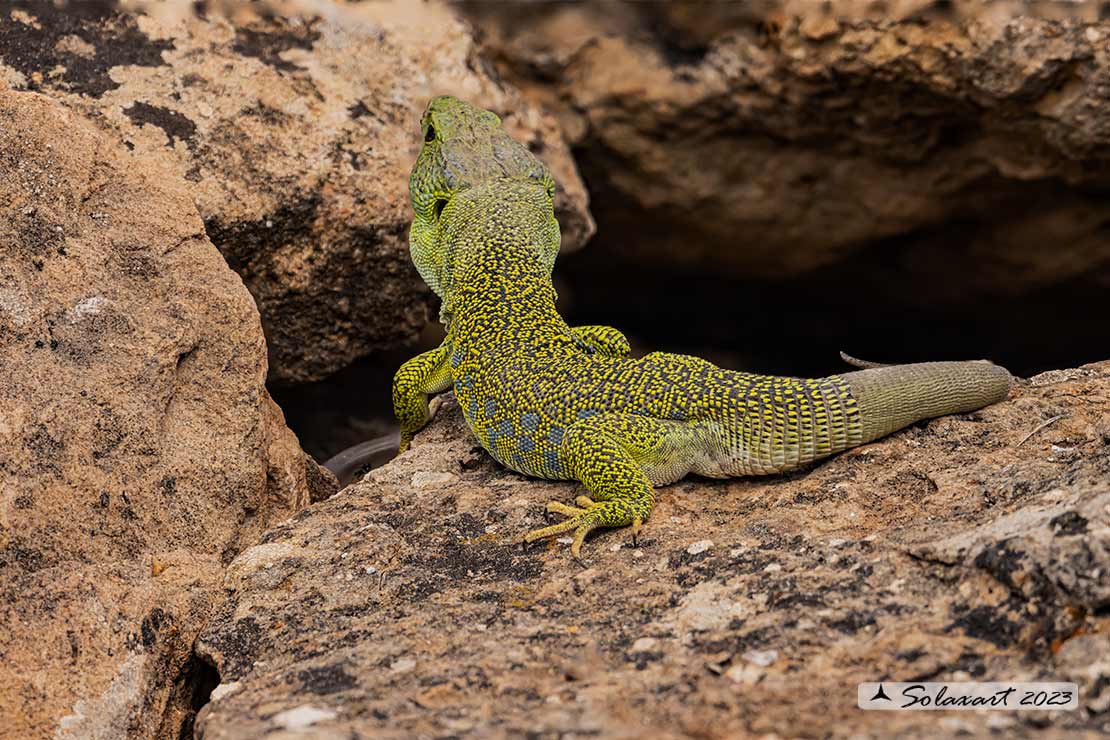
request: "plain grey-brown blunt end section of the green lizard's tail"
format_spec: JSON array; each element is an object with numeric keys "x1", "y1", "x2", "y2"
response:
[{"x1": 840, "y1": 362, "x2": 1012, "y2": 443}]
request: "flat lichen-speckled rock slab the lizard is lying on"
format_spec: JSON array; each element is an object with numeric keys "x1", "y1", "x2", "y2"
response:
[{"x1": 196, "y1": 363, "x2": 1110, "y2": 740}]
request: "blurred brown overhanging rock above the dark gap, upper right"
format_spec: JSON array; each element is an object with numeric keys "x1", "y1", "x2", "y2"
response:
[{"x1": 466, "y1": 1, "x2": 1110, "y2": 304}]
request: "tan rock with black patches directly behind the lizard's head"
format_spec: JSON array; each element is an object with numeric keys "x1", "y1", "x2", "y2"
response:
[{"x1": 0, "y1": 1, "x2": 594, "y2": 383}]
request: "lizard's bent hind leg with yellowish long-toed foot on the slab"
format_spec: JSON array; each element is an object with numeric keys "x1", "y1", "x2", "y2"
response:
[{"x1": 524, "y1": 414, "x2": 688, "y2": 558}]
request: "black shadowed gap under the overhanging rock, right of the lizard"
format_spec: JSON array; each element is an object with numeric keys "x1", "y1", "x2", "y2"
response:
[{"x1": 561, "y1": 236, "x2": 1110, "y2": 377}]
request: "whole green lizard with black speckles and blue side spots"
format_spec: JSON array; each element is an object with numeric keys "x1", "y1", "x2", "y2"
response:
[{"x1": 393, "y1": 97, "x2": 1010, "y2": 557}]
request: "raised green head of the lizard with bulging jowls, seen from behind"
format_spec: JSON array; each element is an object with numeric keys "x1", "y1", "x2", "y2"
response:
[{"x1": 408, "y1": 95, "x2": 559, "y2": 321}]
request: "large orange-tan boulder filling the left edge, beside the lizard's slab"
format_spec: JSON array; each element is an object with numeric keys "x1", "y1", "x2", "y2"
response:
[{"x1": 0, "y1": 91, "x2": 330, "y2": 738}]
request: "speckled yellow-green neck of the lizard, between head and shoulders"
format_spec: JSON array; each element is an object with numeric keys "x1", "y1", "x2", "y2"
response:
[{"x1": 439, "y1": 181, "x2": 566, "y2": 343}]
